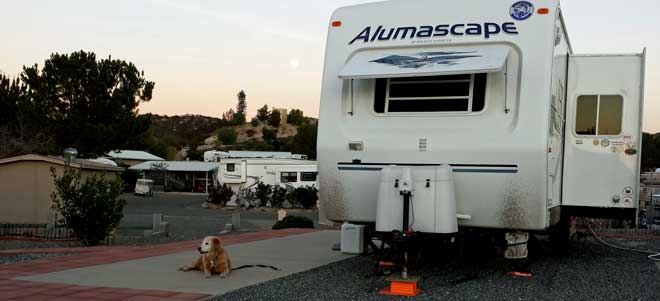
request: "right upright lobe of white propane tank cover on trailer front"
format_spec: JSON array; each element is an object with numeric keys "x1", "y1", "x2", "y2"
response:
[{"x1": 435, "y1": 164, "x2": 458, "y2": 233}]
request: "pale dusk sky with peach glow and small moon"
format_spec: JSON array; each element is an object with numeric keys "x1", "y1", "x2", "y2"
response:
[{"x1": 0, "y1": 0, "x2": 660, "y2": 133}]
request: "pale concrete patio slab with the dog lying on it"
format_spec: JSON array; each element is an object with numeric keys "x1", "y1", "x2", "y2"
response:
[{"x1": 16, "y1": 230, "x2": 351, "y2": 294}]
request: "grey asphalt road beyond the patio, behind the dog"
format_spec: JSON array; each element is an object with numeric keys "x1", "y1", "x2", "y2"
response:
[{"x1": 116, "y1": 193, "x2": 318, "y2": 245}]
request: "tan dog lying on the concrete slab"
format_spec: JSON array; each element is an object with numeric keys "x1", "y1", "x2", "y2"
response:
[{"x1": 179, "y1": 236, "x2": 231, "y2": 278}]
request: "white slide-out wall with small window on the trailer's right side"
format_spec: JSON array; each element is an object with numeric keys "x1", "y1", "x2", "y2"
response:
[{"x1": 562, "y1": 54, "x2": 645, "y2": 209}]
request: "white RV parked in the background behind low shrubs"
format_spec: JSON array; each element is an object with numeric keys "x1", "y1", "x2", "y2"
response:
[{"x1": 218, "y1": 158, "x2": 318, "y2": 191}]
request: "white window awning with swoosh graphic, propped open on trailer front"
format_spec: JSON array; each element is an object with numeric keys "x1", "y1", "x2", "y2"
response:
[{"x1": 339, "y1": 46, "x2": 509, "y2": 79}]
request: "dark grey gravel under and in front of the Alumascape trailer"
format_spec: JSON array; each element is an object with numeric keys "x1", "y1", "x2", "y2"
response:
[{"x1": 216, "y1": 238, "x2": 660, "y2": 300}]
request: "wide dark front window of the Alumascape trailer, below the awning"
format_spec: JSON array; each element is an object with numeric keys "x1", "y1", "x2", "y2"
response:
[{"x1": 374, "y1": 73, "x2": 487, "y2": 113}]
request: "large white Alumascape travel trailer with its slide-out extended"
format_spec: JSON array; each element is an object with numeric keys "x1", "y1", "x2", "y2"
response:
[{"x1": 318, "y1": 0, "x2": 645, "y2": 233}]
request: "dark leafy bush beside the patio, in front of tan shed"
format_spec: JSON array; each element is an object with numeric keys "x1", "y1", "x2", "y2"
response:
[{"x1": 50, "y1": 168, "x2": 126, "y2": 246}]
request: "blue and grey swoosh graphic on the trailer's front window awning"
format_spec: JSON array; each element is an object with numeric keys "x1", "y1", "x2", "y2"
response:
[{"x1": 371, "y1": 51, "x2": 481, "y2": 69}]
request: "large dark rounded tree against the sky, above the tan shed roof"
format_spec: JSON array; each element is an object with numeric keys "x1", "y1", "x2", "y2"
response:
[{"x1": 20, "y1": 51, "x2": 155, "y2": 157}]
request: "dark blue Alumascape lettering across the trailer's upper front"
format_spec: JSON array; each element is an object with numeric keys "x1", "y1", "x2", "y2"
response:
[{"x1": 348, "y1": 22, "x2": 518, "y2": 45}]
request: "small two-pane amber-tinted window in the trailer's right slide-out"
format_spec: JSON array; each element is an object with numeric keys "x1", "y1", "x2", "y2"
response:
[{"x1": 575, "y1": 95, "x2": 623, "y2": 135}]
